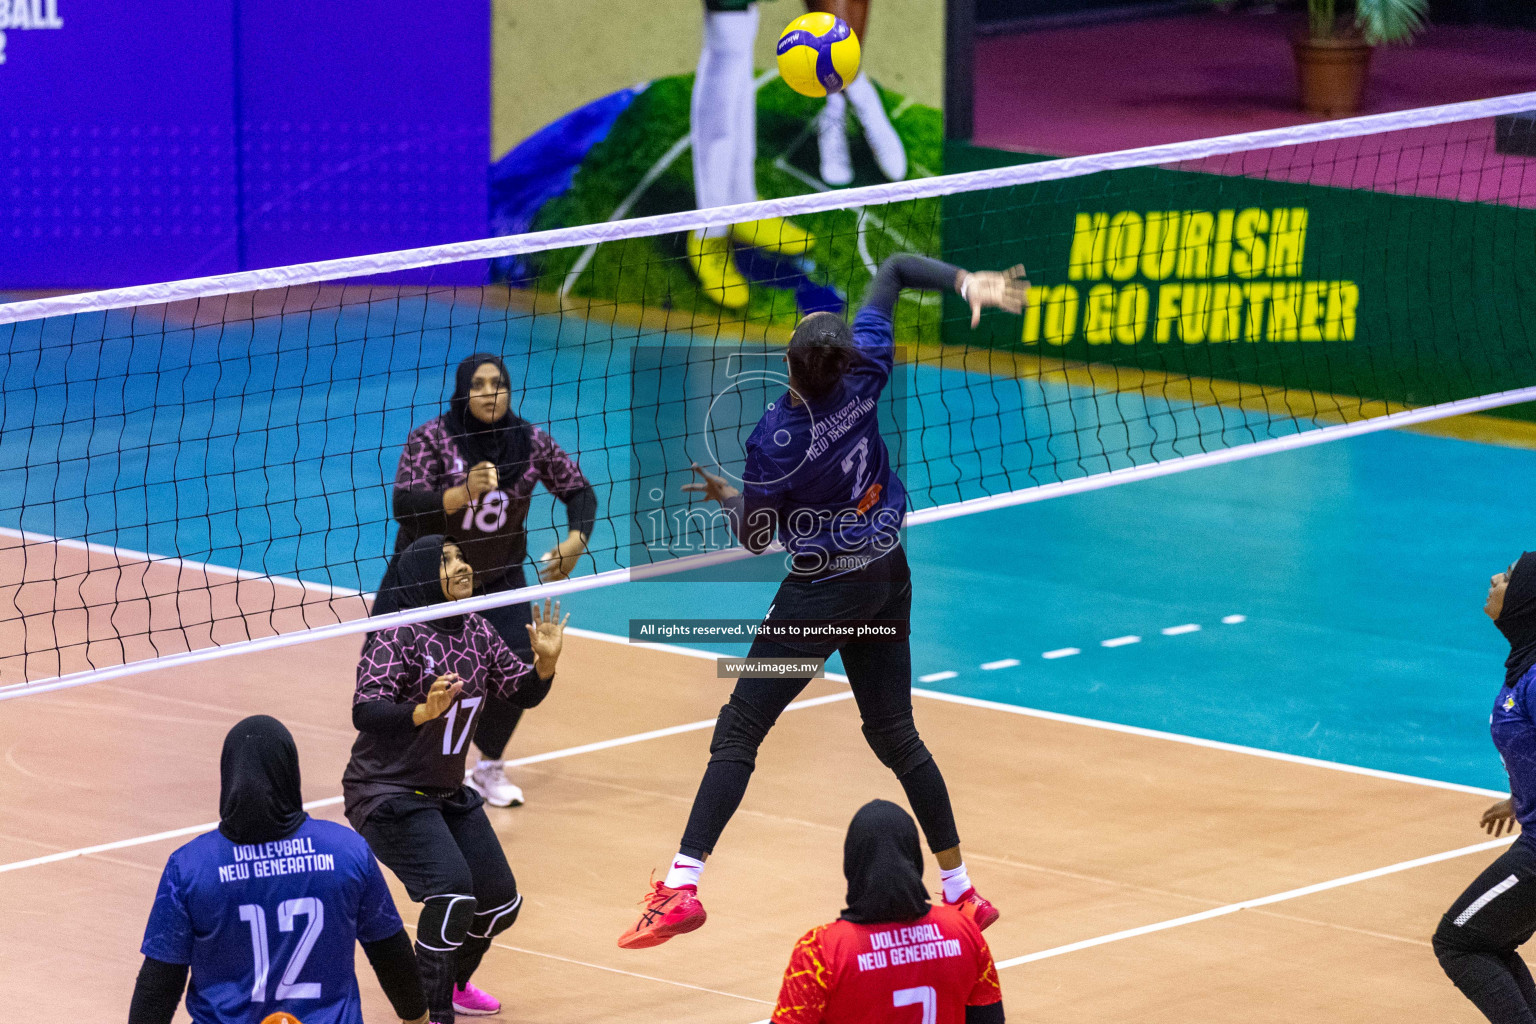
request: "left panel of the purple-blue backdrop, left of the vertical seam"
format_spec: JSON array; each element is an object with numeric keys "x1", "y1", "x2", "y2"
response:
[{"x1": 0, "y1": 0, "x2": 237, "y2": 289}]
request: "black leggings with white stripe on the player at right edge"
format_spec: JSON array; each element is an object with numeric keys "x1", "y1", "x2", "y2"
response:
[{"x1": 1435, "y1": 835, "x2": 1536, "y2": 1024}]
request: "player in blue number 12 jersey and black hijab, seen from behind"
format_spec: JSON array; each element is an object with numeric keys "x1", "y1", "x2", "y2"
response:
[{"x1": 127, "y1": 715, "x2": 427, "y2": 1024}]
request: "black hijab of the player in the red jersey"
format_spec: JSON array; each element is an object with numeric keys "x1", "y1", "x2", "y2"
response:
[{"x1": 842, "y1": 800, "x2": 929, "y2": 924}]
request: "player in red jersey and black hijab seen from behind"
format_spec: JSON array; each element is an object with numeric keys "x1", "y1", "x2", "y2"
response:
[{"x1": 773, "y1": 800, "x2": 1003, "y2": 1024}]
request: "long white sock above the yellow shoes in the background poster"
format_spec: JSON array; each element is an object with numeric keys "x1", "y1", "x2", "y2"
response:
[{"x1": 690, "y1": 5, "x2": 757, "y2": 235}]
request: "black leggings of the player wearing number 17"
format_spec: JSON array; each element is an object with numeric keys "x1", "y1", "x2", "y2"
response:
[{"x1": 361, "y1": 788, "x2": 522, "y2": 1021}]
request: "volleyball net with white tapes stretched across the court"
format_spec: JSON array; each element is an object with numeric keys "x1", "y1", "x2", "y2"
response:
[{"x1": 0, "y1": 94, "x2": 1536, "y2": 697}]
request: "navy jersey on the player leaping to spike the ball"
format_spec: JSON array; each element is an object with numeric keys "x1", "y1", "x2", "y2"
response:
[{"x1": 742, "y1": 306, "x2": 906, "y2": 570}]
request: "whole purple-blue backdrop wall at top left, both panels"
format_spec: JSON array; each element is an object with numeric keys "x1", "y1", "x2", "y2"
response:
[{"x1": 0, "y1": 0, "x2": 490, "y2": 290}]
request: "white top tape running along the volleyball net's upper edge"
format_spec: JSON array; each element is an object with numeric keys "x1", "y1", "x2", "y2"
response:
[{"x1": 0, "y1": 92, "x2": 1536, "y2": 324}]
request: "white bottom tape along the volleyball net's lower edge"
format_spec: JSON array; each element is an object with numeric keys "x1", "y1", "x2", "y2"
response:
[{"x1": 12, "y1": 380, "x2": 1536, "y2": 700}]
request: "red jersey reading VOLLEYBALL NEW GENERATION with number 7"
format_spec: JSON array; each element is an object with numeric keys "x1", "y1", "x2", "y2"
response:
[{"x1": 773, "y1": 904, "x2": 1003, "y2": 1024}]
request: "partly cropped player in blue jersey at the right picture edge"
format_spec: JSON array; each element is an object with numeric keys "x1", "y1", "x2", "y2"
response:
[{"x1": 1435, "y1": 551, "x2": 1536, "y2": 1024}]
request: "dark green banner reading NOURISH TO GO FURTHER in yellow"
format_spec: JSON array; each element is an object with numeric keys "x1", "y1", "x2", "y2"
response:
[{"x1": 943, "y1": 155, "x2": 1536, "y2": 418}]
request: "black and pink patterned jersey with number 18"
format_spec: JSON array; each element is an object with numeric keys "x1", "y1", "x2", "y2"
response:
[{"x1": 395, "y1": 416, "x2": 594, "y2": 588}]
